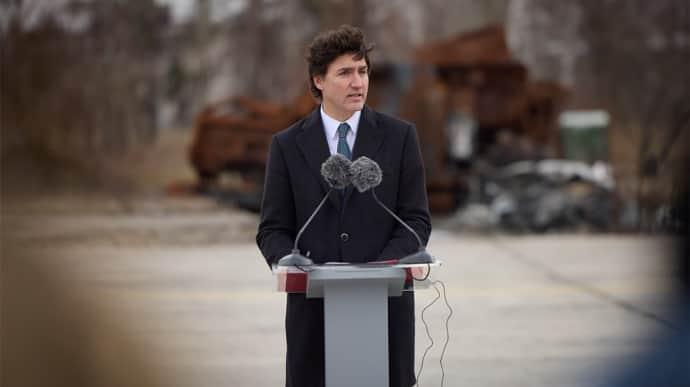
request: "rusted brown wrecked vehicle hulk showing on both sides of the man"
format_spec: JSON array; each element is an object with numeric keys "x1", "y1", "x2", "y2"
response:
[{"x1": 190, "y1": 27, "x2": 565, "y2": 214}]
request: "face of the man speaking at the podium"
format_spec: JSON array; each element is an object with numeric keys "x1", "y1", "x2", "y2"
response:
[{"x1": 314, "y1": 54, "x2": 369, "y2": 121}]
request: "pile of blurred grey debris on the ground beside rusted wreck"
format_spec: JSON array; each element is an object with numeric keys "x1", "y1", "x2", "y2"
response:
[{"x1": 458, "y1": 160, "x2": 617, "y2": 232}]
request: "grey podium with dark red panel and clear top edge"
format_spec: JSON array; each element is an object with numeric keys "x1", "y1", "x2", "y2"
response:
[{"x1": 274, "y1": 262, "x2": 439, "y2": 387}]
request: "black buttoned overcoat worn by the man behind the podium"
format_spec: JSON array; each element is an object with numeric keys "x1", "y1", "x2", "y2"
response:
[{"x1": 256, "y1": 106, "x2": 431, "y2": 387}]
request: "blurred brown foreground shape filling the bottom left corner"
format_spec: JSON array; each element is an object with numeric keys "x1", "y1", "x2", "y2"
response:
[{"x1": 0, "y1": 249, "x2": 169, "y2": 387}]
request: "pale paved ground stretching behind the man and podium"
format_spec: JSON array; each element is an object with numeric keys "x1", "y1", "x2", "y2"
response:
[{"x1": 3, "y1": 199, "x2": 670, "y2": 387}]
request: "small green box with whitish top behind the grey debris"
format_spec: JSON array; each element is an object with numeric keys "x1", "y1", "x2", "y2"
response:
[{"x1": 558, "y1": 110, "x2": 609, "y2": 163}]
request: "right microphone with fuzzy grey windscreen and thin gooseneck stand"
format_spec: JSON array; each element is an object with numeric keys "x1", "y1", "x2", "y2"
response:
[{"x1": 350, "y1": 156, "x2": 434, "y2": 264}]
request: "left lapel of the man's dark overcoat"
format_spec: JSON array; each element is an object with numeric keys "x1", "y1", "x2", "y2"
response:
[{"x1": 297, "y1": 107, "x2": 341, "y2": 209}]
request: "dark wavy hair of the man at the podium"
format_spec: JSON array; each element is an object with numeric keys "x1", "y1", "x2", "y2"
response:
[{"x1": 307, "y1": 24, "x2": 374, "y2": 99}]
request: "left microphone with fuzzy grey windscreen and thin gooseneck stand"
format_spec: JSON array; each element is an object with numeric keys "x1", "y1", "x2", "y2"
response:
[{"x1": 278, "y1": 153, "x2": 352, "y2": 266}]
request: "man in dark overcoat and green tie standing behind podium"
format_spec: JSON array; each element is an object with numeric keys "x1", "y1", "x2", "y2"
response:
[{"x1": 256, "y1": 26, "x2": 431, "y2": 387}]
